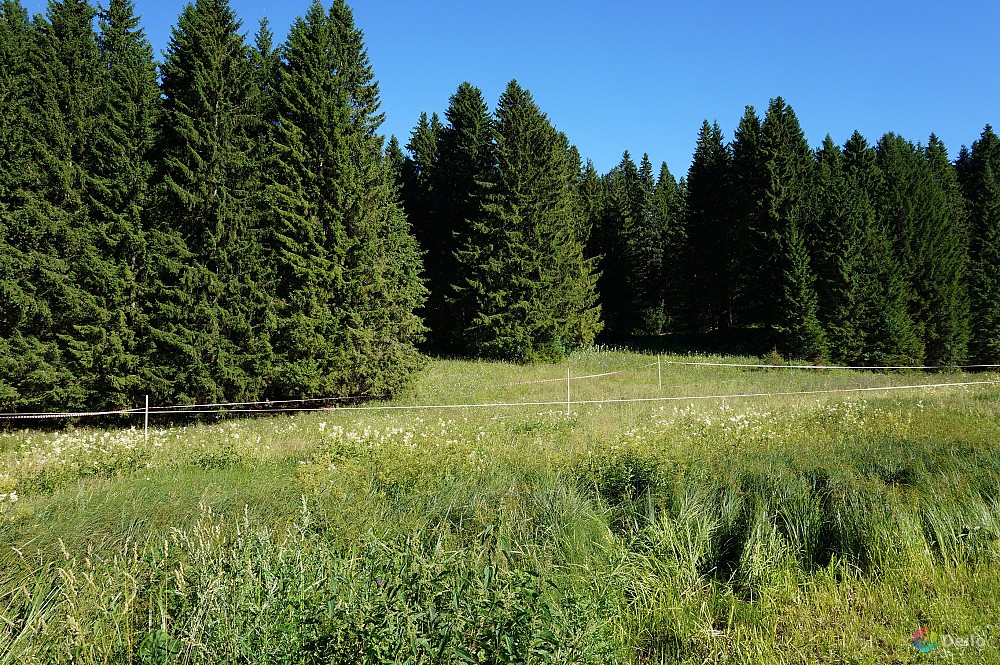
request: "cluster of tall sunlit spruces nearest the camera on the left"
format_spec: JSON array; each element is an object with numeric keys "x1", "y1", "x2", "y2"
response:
[{"x1": 0, "y1": 0, "x2": 426, "y2": 411}]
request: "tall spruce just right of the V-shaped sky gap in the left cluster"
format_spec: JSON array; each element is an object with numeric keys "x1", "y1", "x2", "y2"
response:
[{"x1": 146, "y1": 0, "x2": 271, "y2": 403}]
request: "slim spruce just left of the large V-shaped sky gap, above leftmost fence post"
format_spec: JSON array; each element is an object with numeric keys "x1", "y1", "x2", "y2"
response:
[{"x1": 76, "y1": 0, "x2": 159, "y2": 408}]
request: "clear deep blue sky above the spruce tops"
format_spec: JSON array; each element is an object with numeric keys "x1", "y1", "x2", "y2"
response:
[{"x1": 22, "y1": 0, "x2": 1000, "y2": 176}]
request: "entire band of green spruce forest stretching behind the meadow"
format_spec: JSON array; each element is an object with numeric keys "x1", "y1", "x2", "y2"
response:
[{"x1": 0, "y1": 0, "x2": 1000, "y2": 412}]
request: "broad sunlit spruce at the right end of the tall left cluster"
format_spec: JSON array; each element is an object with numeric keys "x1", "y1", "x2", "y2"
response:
[{"x1": 269, "y1": 0, "x2": 425, "y2": 397}]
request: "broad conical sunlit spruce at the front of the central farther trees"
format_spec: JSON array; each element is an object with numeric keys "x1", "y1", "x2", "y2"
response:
[{"x1": 457, "y1": 81, "x2": 600, "y2": 361}]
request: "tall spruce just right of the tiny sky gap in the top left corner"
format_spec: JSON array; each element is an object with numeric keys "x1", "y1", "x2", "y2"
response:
[{"x1": 8, "y1": 0, "x2": 107, "y2": 408}]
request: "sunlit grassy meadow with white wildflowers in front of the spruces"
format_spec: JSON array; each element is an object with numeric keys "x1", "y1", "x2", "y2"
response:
[{"x1": 0, "y1": 349, "x2": 1000, "y2": 665}]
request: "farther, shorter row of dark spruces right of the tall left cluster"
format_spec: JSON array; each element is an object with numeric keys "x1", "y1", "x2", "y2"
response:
[{"x1": 398, "y1": 91, "x2": 1000, "y2": 366}]
